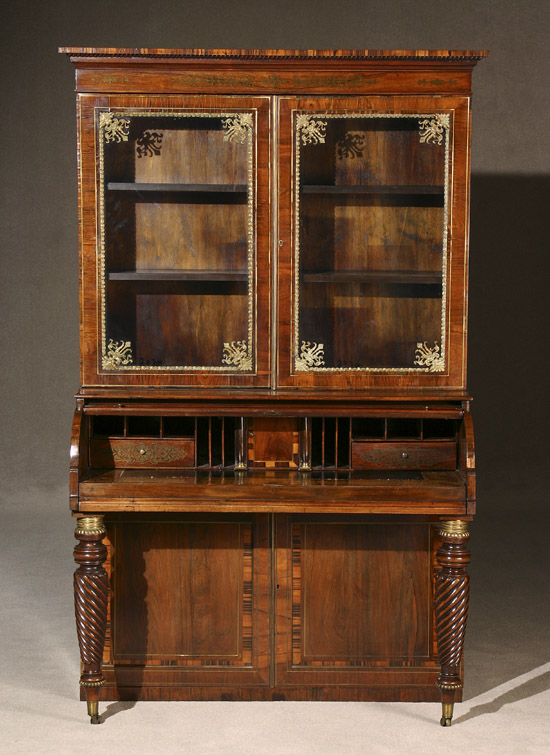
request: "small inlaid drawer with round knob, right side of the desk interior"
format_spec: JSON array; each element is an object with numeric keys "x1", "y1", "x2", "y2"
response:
[{"x1": 351, "y1": 441, "x2": 456, "y2": 470}]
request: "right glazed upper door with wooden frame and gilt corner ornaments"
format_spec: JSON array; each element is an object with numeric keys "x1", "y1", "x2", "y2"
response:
[{"x1": 279, "y1": 97, "x2": 469, "y2": 389}]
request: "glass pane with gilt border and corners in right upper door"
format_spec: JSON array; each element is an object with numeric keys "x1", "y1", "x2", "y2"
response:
[{"x1": 292, "y1": 111, "x2": 450, "y2": 373}]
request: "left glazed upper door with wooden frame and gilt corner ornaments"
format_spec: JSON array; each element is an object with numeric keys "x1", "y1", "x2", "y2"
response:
[{"x1": 79, "y1": 95, "x2": 270, "y2": 387}]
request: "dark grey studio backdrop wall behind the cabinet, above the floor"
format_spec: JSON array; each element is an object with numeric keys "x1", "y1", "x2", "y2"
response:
[{"x1": 0, "y1": 0, "x2": 550, "y2": 496}]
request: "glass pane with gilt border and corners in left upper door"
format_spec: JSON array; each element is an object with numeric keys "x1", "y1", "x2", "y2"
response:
[{"x1": 96, "y1": 108, "x2": 256, "y2": 374}]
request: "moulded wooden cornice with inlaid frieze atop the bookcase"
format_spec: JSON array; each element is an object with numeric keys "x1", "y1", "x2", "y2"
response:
[{"x1": 59, "y1": 47, "x2": 488, "y2": 94}]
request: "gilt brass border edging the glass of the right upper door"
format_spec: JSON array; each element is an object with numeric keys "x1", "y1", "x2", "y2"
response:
[{"x1": 292, "y1": 110, "x2": 451, "y2": 374}]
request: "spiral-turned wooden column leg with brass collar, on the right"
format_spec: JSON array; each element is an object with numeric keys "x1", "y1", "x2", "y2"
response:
[{"x1": 435, "y1": 520, "x2": 470, "y2": 726}]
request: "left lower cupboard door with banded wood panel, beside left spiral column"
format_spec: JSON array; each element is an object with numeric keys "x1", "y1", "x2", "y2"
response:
[{"x1": 105, "y1": 514, "x2": 271, "y2": 699}]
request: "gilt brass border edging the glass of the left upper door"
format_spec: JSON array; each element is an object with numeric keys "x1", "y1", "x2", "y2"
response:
[{"x1": 95, "y1": 108, "x2": 257, "y2": 372}]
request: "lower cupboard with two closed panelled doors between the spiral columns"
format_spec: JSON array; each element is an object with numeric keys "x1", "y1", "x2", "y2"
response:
[{"x1": 91, "y1": 514, "x2": 452, "y2": 701}]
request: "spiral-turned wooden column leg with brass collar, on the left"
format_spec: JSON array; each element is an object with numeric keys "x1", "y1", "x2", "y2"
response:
[{"x1": 74, "y1": 516, "x2": 108, "y2": 724}]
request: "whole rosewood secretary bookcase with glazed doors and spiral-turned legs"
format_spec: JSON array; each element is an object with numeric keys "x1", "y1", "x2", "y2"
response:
[{"x1": 61, "y1": 48, "x2": 486, "y2": 725}]
